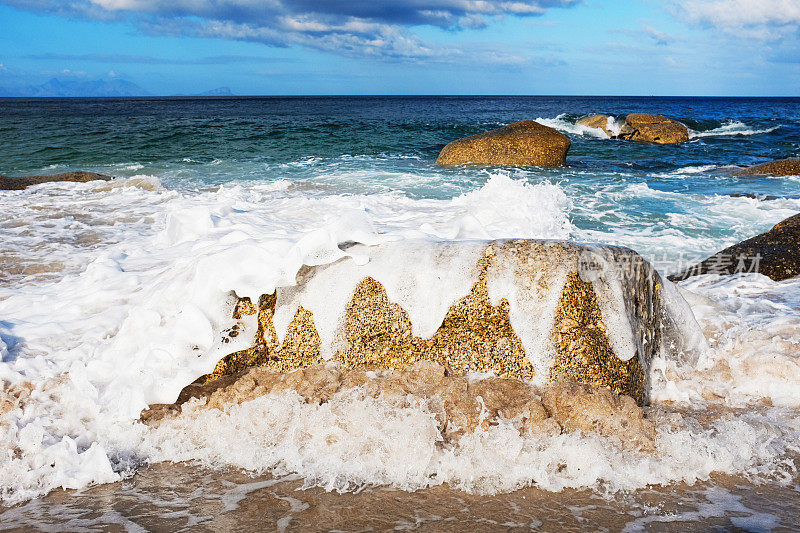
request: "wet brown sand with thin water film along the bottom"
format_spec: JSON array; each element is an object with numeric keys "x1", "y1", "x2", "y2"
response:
[{"x1": 0, "y1": 463, "x2": 800, "y2": 533}]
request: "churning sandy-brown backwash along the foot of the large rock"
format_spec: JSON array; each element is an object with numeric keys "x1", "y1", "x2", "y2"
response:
[{"x1": 142, "y1": 360, "x2": 655, "y2": 453}]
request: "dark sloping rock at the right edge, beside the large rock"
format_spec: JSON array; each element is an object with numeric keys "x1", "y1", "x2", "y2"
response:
[{"x1": 669, "y1": 214, "x2": 800, "y2": 281}]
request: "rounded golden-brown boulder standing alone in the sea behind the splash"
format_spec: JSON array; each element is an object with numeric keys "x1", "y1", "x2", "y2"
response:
[{"x1": 436, "y1": 120, "x2": 570, "y2": 167}]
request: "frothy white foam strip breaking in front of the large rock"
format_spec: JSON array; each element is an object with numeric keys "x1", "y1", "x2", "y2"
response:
[{"x1": 141, "y1": 390, "x2": 798, "y2": 494}]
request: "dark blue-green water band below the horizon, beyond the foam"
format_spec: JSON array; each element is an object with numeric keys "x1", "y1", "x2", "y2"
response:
[{"x1": 0, "y1": 96, "x2": 800, "y2": 186}]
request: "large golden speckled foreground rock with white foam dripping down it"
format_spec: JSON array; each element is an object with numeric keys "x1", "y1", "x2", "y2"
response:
[{"x1": 207, "y1": 240, "x2": 704, "y2": 404}]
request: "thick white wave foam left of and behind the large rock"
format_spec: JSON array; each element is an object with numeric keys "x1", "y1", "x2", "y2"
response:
[{"x1": 0, "y1": 173, "x2": 574, "y2": 501}]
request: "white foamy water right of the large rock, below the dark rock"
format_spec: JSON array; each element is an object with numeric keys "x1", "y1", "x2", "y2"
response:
[{"x1": 652, "y1": 274, "x2": 800, "y2": 407}]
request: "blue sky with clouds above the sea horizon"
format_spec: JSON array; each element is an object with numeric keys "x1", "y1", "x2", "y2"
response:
[{"x1": 0, "y1": 0, "x2": 800, "y2": 96}]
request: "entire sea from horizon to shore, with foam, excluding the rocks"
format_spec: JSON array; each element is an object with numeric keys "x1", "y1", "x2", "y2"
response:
[{"x1": 0, "y1": 96, "x2": 800, "y2": 531}]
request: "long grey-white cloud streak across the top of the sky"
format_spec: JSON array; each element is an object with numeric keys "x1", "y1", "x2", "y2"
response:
[{"x1": 5, "y1": 0, "x2": 582, "y2": 60}]
